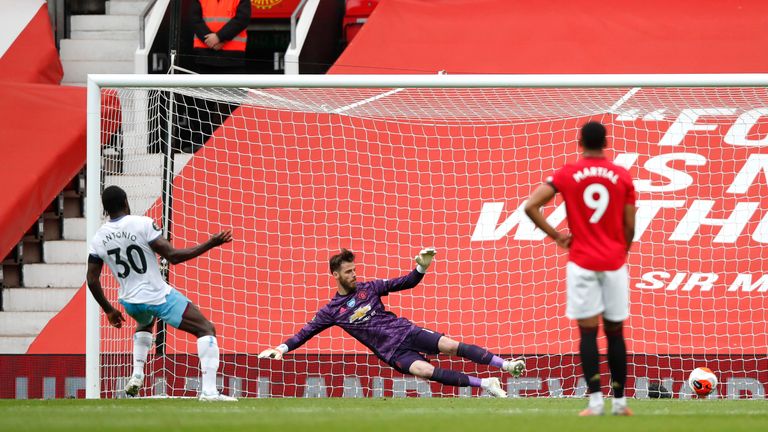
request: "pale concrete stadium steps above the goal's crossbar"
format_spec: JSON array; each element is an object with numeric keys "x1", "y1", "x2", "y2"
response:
[{"x1": 60, "y1": 0, "x2": 148, "y2": 85}]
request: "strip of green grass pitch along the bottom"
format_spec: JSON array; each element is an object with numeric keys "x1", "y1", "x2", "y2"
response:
[{"x1": 0, "y1": 398, "x2": 768, "y2": 432}]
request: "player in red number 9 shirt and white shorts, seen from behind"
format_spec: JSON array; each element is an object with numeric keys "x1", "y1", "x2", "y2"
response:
[{"x1": 525, "y1": 122, "x2": 636, "y2": 416}]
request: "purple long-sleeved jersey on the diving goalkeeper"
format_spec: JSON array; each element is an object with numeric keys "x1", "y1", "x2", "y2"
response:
[{"x1": 285, "y1": 269, "x2": 424, "y2": 362}]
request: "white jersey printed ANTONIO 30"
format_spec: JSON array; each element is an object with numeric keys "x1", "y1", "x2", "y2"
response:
[{"x1": 88, "y1": 215, "x2": 171, "y2": 305}]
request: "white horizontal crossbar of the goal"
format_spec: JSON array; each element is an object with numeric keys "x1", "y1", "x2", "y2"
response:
[{"x1": 90, "y1": 73, "x2": 768, "y2": 88}]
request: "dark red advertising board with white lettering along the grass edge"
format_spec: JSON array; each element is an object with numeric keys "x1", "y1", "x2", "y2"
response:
[{"x1": 0, "y1": 355, "x2": 768, "y2": 399}]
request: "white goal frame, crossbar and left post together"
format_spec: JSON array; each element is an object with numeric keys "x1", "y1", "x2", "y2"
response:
[{"x1": 85, "y1": 74, "x2": 768, "y2": 399}]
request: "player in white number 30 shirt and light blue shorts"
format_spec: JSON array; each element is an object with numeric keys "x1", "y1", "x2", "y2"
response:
[{"x1": 87, "y1": 186, "x2": 237, "y2": 401}]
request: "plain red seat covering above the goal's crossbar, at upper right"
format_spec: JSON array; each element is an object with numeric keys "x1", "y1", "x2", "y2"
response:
[{"x1": 329, "y1": 0, "x2": 768, "y2": 74}]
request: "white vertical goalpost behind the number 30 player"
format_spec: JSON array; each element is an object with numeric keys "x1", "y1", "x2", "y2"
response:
[{"x1": 85, "y1": 77, "x2": 101, "y2": 399}]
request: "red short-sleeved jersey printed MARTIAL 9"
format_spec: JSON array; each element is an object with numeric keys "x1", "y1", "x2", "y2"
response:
[{"x1": 548, "y1": 157, "x2": 635, "y2": 271}]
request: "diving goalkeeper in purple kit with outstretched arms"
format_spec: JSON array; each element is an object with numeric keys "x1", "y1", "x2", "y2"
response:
[{"x1": 259, "y1": 248, "x2": 525, "y2": 397}]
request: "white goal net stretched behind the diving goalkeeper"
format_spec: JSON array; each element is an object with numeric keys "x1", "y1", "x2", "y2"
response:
[{"x1": 88, "y1": 76, "x2": 768, "y2": 398}]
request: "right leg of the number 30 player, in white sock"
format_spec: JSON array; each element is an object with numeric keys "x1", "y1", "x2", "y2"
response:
[{"x1": 179, "y1": 303, "x2": 237, "y2": 402}]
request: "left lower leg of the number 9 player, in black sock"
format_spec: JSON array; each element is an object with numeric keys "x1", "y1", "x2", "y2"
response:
[{"x1": 578, "y1": 316, "x2": 604, "y2": 416}]
